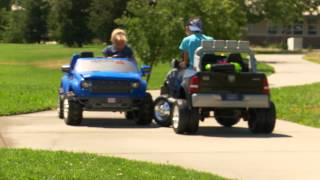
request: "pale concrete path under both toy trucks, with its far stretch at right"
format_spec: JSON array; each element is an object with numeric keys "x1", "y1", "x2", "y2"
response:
[{"x1": 0, "y1": 55, "x2": 320, "y2": 179}]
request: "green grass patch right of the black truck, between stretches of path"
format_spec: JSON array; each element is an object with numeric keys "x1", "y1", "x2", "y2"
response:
[{"x1": 272, "y1": 83, "x2": 320, "y2": 128}]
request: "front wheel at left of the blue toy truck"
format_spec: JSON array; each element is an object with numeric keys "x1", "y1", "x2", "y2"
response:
[{"x1": 64, "y1": 99, "x2": 83, "y2": 126}]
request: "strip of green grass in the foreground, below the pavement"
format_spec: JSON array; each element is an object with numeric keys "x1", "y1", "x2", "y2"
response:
[{"x1": 0, "y1": 149, "x2": 225, "y2": 180}]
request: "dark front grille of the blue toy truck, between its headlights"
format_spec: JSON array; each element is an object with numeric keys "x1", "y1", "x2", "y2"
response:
[{"x1": 91, "y1": 80, "x2": 131, "y2": 93}]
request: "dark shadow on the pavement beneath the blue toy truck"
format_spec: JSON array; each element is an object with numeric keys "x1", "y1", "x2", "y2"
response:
[{"x1": 80, "y1": 118, "x2": 159, "y2": 129}]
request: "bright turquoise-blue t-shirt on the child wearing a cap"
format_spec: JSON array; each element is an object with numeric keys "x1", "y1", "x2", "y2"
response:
[{"x1": 179, "y1": 33, "x2": 214, "y2": 67}]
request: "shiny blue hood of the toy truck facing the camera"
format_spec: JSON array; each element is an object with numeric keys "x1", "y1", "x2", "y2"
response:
[{"x1": 80, "y1": 72, "x2": 141, "y2": 81}]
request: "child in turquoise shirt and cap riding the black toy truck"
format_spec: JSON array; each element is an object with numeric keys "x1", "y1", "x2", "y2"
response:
[{"x1": 179, "y1": 18, "x2": 213, "y2": 69}]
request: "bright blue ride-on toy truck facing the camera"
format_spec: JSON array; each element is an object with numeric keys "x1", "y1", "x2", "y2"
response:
[{"x1": 58, "y1": 52, "x2": 153, "y2": 125}]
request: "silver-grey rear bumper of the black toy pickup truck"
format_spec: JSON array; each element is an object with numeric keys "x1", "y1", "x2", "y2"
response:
[{"x1": 191, "y1": 94, "x2": 270, "y2": 108}]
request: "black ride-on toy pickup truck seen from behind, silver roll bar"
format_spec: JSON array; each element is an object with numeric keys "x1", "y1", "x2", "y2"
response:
[{"x1": 154, "y1": 40, "x2": 276, "y2": 134}]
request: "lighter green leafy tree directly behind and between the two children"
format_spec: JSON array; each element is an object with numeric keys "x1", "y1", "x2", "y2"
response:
[{"x1": 117, "y1": 0, "x2": 246, "y2": 80}]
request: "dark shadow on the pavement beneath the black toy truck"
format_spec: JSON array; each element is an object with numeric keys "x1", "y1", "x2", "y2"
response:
[{"x1": 197, "y1": 126, "x2": 292, "y2": 138}]
